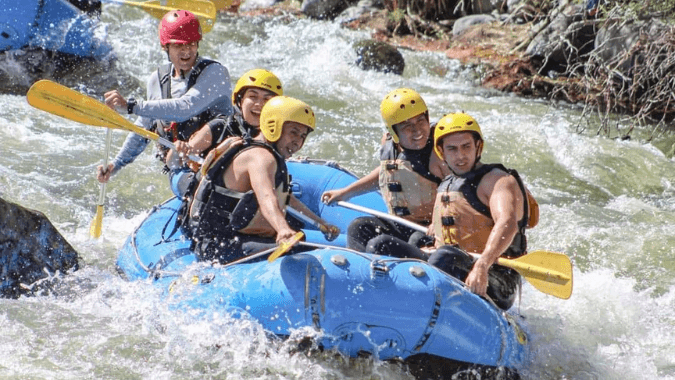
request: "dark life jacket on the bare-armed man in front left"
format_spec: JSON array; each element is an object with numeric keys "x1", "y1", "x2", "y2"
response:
[{"x1": 182, "y1": 139, "x2": 290, "y2": 241}]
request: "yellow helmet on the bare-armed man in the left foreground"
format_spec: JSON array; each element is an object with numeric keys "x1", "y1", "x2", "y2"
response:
[{"x1": 260, "y1": 96, "x2": 316, "y2": 142}]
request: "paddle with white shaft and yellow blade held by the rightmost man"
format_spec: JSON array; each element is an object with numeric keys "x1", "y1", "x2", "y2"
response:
[{"x1": 337, "y1": 201, "x2": 573, "y2": 299}]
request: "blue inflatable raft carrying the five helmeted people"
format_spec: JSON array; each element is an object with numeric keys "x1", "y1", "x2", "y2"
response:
[{"x1": 117, "y1": 162, "x2": 527, "y2": 378}]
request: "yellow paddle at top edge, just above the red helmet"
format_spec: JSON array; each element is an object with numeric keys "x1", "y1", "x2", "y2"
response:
[{"x1": 104, "y1": 0, "x2": 216, "y2": 33}]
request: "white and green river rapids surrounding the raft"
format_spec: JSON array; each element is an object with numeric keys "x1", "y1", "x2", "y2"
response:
[{"x1": 0, "y1": 6, "x2": 675, "y2": 379}]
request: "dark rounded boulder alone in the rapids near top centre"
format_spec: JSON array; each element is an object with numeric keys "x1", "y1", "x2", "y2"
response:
[{"x1": 354, "y1": 40, "x2": 405, "y2": 75}]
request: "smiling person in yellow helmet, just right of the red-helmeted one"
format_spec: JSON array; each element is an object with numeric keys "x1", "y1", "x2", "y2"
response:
[{"x1": 167, "y1": 69, "x2": 284, "y2": 171}]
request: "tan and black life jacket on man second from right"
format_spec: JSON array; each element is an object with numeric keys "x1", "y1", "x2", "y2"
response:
[{"x1": 379, "y1": 129, "x2": 441, "y2": 224}]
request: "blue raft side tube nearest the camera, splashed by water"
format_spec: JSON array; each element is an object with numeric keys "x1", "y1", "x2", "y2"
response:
[{"x1": 162, "y1": 249, "x2": 526, "y2": 368}]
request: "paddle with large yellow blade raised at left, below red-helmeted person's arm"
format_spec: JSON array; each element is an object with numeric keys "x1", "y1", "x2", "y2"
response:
[{"x1": 26, "y1": 79, "x2": 204, "y2": 163}]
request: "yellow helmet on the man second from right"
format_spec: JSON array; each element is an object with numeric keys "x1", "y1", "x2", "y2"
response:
[{"x1": 380, "y1": 88, "x2": 428, "y2": 143}]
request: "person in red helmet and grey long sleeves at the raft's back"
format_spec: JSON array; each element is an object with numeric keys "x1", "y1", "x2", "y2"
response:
[{"x1": 97, "y1": 10, "x2": 233, "y2": 182}]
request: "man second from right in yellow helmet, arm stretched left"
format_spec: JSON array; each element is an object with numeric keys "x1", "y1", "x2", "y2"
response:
[{"x1": 322, "y1": 88, "x2": 450, "y2": 252}]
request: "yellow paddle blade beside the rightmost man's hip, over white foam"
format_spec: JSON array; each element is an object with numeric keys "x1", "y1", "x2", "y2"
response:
[{"x1": 497, "y1": 251, "x2": 573, "y2": 299}]
